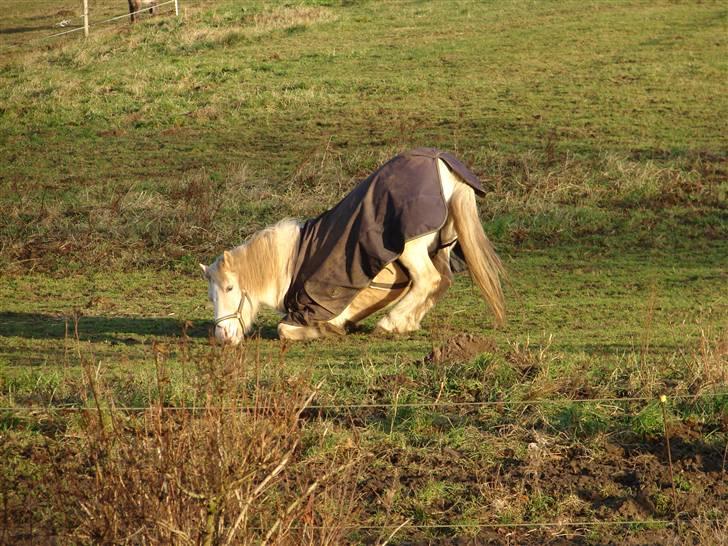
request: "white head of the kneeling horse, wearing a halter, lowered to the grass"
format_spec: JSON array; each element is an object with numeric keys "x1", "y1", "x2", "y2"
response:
[{"x1": 200, "y1": 251, "x2": 255, "y2": 345}]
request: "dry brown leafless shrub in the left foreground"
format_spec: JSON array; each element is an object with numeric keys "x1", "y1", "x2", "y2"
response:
[{"x1": 71, "y1": 350, "x2": 357, "y2": 544}]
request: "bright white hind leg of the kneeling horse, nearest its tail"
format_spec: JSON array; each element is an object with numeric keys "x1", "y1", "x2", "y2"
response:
[{"x1": 377, "y1": 236, "x2": 440, "y2": 334}]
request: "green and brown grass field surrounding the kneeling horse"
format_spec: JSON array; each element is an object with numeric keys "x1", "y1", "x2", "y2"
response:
[{"x1": 0, "y1": 0, "x2": 728, "y2": 544}]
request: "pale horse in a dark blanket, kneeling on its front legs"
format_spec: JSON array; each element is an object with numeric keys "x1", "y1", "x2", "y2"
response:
[{"x1": 199, "y1": 148, "x2": 505, "y2": 345}]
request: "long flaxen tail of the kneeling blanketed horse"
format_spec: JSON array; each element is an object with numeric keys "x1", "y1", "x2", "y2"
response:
[{"x1": 450, "y1": 183, "x2": 506, "y2": 324}]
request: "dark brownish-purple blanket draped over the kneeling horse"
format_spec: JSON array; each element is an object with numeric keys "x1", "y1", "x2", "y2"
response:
[{"x1": 284, "y1": 148, "x2": 485, "y2": 326}]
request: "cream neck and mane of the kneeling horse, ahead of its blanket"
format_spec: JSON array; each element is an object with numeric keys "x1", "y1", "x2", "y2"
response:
[{"x1": 247, "y1": 220, "x2": 301, "y2": 312}]
